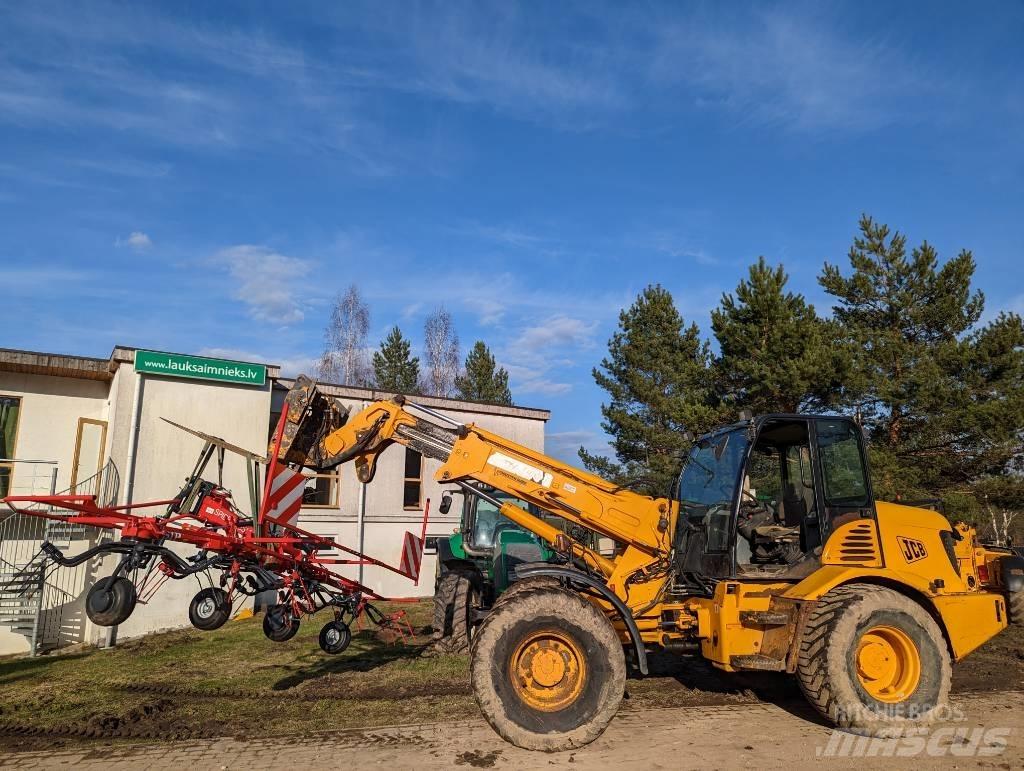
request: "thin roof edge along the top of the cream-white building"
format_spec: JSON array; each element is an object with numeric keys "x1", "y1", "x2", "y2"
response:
[{"x1": 0, "y1": 345, "x2": 551, "y2": 421}]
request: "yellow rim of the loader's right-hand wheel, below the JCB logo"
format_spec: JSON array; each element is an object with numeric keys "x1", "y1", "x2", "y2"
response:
[{"x1": 857, "y1": 626, "x2": 921, "y2": 703}]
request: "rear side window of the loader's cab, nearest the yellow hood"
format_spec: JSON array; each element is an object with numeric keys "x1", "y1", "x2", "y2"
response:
[{"x1": 812, "y1": 418, "x2": 874, "y2": 544}]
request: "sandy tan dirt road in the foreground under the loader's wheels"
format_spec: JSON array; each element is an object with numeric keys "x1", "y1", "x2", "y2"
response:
[{"x1": 0, "y1": 692, "x2": 1024, "y2": 771}]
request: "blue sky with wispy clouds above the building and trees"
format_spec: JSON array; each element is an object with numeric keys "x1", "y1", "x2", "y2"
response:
[{"x1": 0, "y1": 2, "x2": 1024, "y2": 458}]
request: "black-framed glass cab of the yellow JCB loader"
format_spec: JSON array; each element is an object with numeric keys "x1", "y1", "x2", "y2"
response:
[{"x1": 677, "y1": 415, "x2": 874, "y2": 579}]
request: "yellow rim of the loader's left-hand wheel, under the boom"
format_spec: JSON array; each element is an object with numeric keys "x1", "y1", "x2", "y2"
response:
[{"x1": 509, "y1": 630, "x2": 587, "y2": 712}]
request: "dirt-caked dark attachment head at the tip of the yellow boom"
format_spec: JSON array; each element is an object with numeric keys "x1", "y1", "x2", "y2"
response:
[{"x1": 270, "y1": 375, "x2": 348, "y2": 468}]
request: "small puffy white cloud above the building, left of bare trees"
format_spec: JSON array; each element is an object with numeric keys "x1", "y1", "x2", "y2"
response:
[{"x1": 211, "y1": 244, "x2": 313, "y2": 327}]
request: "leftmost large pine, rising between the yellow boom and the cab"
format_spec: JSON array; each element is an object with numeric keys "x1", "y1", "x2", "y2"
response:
[{"x1": 580, "y1": 286, "x2": 721, "y2": 496}]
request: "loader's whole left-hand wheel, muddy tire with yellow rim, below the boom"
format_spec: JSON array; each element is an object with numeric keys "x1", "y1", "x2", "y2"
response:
[{"x1": 470, "y1": 588, "x2": 626, "y2": 753}]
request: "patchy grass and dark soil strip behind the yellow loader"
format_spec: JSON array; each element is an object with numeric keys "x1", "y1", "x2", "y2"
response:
[{"x1": 0, "y1": 603, "x2": 1024, "y2": 754}]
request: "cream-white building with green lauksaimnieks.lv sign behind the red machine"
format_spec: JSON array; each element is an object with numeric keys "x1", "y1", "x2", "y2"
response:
[{"x1": 0, "y1": 346, "x2": 550, "y2": 654}]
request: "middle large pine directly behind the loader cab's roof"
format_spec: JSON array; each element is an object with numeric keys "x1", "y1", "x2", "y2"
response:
[{"x1": 712, "y1": 257, "x2": 846, "y2": 415}]
